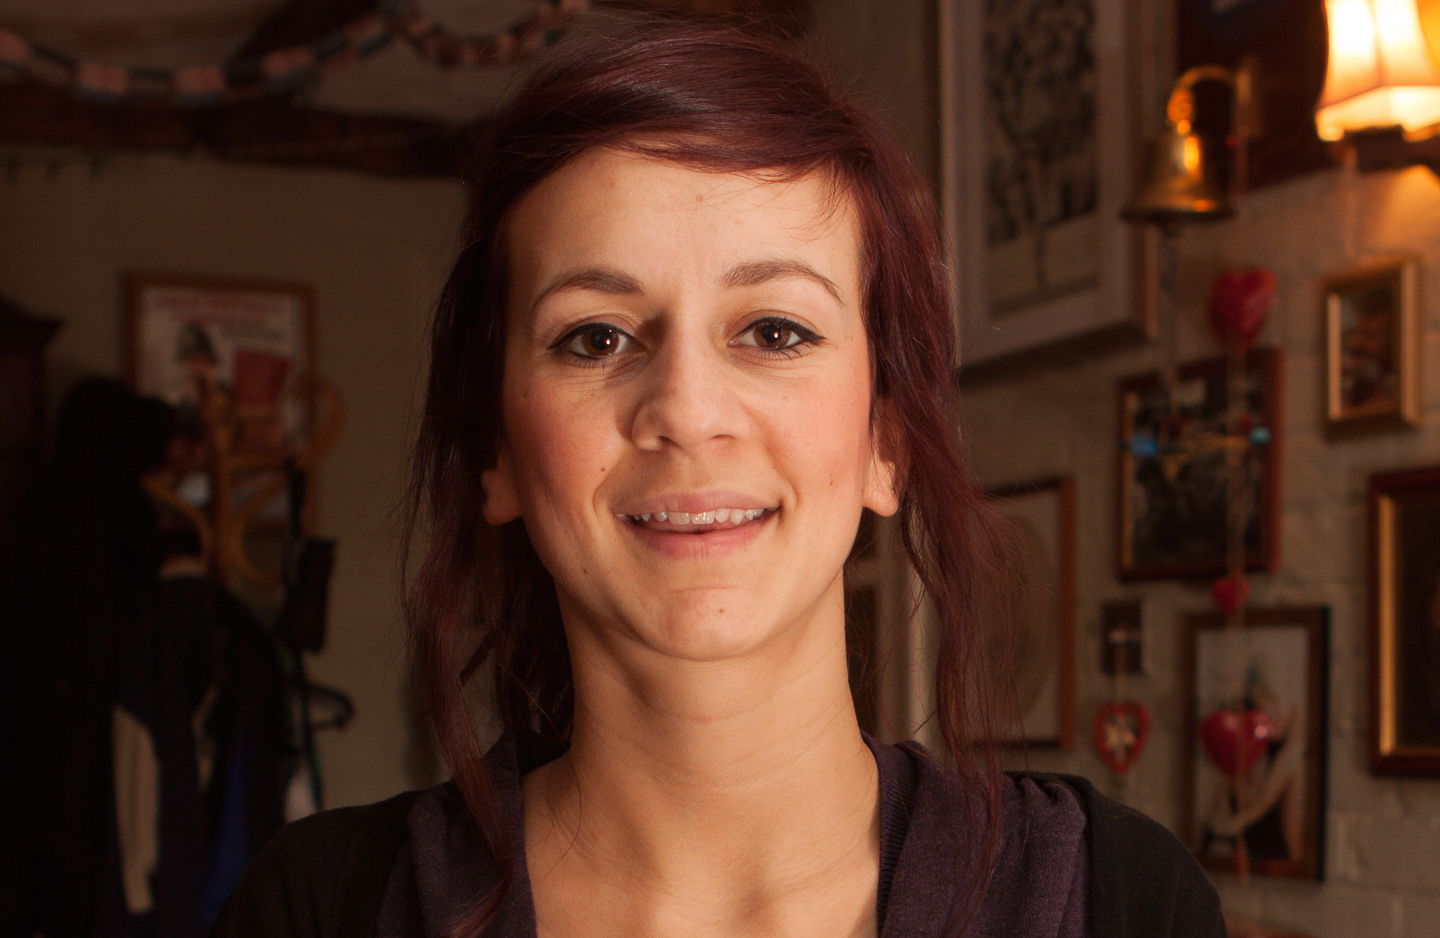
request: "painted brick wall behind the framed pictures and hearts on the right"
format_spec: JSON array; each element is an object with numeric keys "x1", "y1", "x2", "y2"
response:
[{"x1": 816, "y1": 0, "x2": 1440, "y2": 938}]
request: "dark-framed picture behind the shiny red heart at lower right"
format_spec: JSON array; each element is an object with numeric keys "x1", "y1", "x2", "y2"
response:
[{"x1": 1185, "y1": 607, "x2": 1329, "y2": 879}]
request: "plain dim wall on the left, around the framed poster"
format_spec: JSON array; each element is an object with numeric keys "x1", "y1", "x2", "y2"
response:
[{"x1": 0, "y1": 153, "x2": 464, "y2": 805}]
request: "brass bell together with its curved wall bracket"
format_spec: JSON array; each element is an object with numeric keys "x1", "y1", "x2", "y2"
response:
[{"x1": 1120, "y1": 63, "x2": 1255, "y2": 229}]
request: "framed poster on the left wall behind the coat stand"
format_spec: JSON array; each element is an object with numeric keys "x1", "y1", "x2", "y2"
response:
[{"x1": 125, "y1": 274, "x2": 314, "y2": 457}]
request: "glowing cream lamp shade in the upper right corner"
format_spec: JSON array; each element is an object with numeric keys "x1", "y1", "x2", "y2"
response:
[{"x1": 1315, "y1": 0, "x2": 1440, "y2": 140}]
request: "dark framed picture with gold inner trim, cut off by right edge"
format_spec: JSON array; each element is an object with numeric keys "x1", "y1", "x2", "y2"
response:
[{"x1": 1369, "y1": 465, "x2": 1440, "y2": 778}]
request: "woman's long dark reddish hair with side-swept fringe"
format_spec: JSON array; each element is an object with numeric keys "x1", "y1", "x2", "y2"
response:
[{"x1": 409, "y1": 17, "x2": 998, "y2": 934}]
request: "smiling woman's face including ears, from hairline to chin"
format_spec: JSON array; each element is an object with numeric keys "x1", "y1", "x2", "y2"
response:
[{"x1": 484, "y1": 150, "x2": 896, "y2": 660}]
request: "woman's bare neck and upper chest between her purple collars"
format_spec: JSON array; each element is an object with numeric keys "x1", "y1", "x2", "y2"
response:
[{"x1": 524, "y1": 605, "x2": 880, "y2": 935}]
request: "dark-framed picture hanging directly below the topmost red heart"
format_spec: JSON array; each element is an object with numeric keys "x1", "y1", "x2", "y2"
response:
[{"x1": 1116, "y1": 349, "x2": 1282, "y2": 581}]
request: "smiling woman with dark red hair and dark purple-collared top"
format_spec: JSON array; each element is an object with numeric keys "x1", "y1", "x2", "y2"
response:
[{"x1": 219, "y1": 14, "x2": 1223, "y2": 938}]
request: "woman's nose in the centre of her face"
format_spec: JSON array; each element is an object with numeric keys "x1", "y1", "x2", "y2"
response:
[{"x1": 631, "y1": 340, "x2": 747, "y2": 450}]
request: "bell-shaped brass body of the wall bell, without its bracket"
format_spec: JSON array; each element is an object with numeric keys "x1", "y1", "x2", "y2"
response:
[{"x1": 1120, "y1": 124, "x2": 1234, "y2": 226}]
